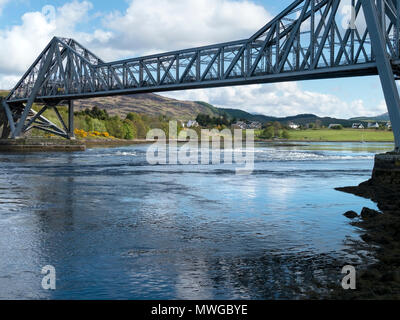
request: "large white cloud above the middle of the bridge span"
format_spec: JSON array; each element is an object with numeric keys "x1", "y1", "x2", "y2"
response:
[{"x1": 103, "y1": 0, "x2": 271, "y2": 53}]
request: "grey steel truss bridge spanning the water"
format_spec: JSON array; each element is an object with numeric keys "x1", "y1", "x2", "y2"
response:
[{"x1": 0, "y1": 0, "x2": 400, "y2": 150}]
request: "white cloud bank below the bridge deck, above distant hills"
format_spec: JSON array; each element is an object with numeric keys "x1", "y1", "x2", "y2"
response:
[{"x1": 163, "y1": 82, "x2": 386, "y2": 118}]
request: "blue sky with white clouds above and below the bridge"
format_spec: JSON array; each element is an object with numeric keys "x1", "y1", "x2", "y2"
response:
[{"x1": 0, "y1": 0, "x2": 386, "y2": 118}]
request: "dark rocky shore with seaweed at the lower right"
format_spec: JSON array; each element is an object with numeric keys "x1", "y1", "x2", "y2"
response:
[{"x1": 334, "y1": 153, "x2": 400, "y2": 300}]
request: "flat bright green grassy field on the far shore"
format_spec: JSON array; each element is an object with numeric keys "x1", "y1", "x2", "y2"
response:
[{"x1": 289, "y1": 129, "x2": 394, "y2": 142}]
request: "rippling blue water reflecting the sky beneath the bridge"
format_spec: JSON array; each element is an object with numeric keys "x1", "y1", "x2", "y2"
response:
[{"x1": 0, "y1": 143, "x2": 393, "y2": 299}]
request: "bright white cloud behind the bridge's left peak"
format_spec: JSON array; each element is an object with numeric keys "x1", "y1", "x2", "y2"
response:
[{"x1": 0, "y1": 0, "x2": 111, "y2": 88}]
